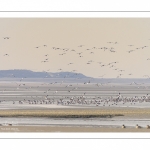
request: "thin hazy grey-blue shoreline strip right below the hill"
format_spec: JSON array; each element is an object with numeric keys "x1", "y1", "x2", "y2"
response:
[{"x1": 0, "y1": 77, "x2": 150, "y2": 87}]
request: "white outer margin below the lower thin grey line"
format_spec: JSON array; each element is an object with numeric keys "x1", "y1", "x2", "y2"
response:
[{"x1": 0, "y1": 139, "x2": 149, "y2": 150}]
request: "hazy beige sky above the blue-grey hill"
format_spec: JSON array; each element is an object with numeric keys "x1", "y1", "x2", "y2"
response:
[{"x1": 0, "y1": 18, "x2": 150, "y2": 78}]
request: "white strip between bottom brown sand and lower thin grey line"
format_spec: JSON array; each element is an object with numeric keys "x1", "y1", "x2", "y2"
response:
[{"x1": 0, "y1": 132, "x2": 150, "y2": 139}]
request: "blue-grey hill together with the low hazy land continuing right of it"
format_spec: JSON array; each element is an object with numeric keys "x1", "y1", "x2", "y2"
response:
[{"x1": 0, "y1": 69, "x2": 150, "y2": 86}]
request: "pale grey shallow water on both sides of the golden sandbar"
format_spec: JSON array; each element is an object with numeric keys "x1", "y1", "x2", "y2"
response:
[{"x1": 0, "y1": 82, "x2": 150, "y2": 127}]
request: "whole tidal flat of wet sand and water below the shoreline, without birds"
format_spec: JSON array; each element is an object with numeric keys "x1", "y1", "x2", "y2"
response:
[{"x1": 0, "y1": 82, "x2": 150, "y2": 132}]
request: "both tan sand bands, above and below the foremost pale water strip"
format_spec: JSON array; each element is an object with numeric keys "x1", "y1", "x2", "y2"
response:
[{"x1": 0, "y1": 108, "x2": 150, "y2": 132}]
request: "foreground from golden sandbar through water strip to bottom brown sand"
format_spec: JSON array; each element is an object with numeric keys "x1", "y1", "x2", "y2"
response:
[{"x1": 0, "y1": 108, "x2": 150, "y2": 132}]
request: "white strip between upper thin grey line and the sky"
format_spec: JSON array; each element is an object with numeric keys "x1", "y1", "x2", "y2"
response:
[{"x1": 0, "y1": 12, "x2": 150, "y2": 18}]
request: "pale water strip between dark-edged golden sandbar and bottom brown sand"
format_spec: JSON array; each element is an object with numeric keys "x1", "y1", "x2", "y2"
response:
[{"x1": 0, "y1": 117, "x2": 150, "y2": 127}]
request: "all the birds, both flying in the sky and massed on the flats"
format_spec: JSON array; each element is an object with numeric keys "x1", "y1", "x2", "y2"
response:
[{"x1": 0, "y1": 37, "x2": 150, "y2": 106}]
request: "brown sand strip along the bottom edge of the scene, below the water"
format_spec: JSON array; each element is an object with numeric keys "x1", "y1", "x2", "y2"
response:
[{"x1": 0, "y1": 126, "x2": 150, "y2": 132}]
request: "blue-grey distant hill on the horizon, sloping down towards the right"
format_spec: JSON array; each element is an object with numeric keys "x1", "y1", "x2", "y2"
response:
[{"x1": 0, "y1": 69, "x2": 89, "y2": 78}]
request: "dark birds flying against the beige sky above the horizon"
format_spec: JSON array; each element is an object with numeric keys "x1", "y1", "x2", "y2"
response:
[{"x1": 3, "y1": 37, "x2": 150, "y2": 79}]
